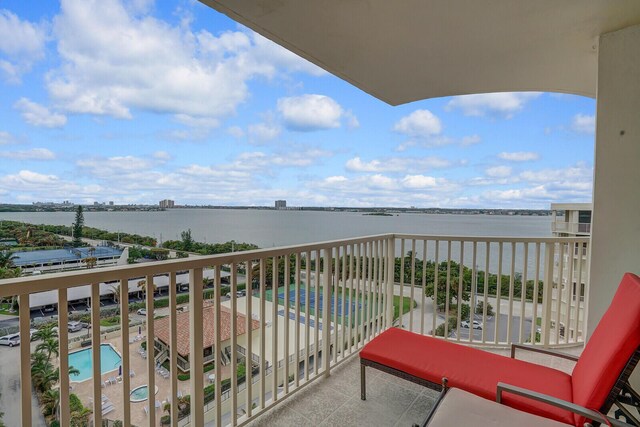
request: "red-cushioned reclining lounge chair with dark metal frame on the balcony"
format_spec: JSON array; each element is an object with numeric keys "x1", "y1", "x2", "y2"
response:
[{"x1": 360, "y1": 273, "x2": 640, "y2": 426}]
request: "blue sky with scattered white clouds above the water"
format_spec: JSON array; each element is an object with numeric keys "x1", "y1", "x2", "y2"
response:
[{"x1": 0, "y1": 0, "x2": 595, "y2": 209}]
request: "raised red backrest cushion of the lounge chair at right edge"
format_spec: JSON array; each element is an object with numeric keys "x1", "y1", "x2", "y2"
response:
[{"x1": 571, "y1": 273, "x2": 640, "y2": 423}]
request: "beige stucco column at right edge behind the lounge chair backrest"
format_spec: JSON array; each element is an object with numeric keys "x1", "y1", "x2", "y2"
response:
[{"x1": 587, "y1": 25, "x2": 640, "y2": 337}]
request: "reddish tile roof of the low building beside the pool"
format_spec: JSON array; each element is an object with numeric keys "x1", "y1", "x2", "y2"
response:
[{"x1": 154, "y1": 304, "x2": 260, "y2": 356}]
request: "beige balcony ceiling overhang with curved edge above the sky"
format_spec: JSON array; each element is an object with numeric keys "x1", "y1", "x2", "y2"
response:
[{"x1": 200, "y1": 0, "x2": 640, "y2": 105}]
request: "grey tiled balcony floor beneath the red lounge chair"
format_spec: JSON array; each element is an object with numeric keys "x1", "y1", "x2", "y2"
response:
[{"x1": 244, "y1": 349, "x2": 581, "y2": 427}]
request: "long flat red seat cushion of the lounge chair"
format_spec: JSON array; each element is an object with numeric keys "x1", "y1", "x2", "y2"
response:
[{"x1": 360, "y1": 328, "x2": 575, "y2": 425}]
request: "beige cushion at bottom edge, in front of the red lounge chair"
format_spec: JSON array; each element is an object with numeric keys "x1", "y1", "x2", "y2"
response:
[{"x1": 428, "y1": 388, "x2": 569, "y2": 427}]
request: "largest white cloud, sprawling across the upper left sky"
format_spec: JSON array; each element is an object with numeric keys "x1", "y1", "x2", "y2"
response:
[{"x1": 47, "y1": 0, "x2": 324, "y2": 125}]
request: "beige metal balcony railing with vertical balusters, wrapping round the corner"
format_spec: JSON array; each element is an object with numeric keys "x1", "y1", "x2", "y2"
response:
[{"x1": 0, "y1": 234, "x2": 589, "y2": 426}]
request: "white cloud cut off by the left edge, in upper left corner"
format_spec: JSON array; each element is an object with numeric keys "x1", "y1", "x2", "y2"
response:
[{"x1": 0, "y1": 10, "x2": 46, "y2": 83}]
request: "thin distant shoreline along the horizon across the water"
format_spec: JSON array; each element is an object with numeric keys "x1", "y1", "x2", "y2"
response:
[{"x1": 0, "y1": 203, "x2": 552, "y2": 216}]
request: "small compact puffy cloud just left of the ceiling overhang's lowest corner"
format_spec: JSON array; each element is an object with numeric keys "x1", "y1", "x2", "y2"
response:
[{"x1": 277, "y1": 94, "x2": 344, "y2": 132}]
